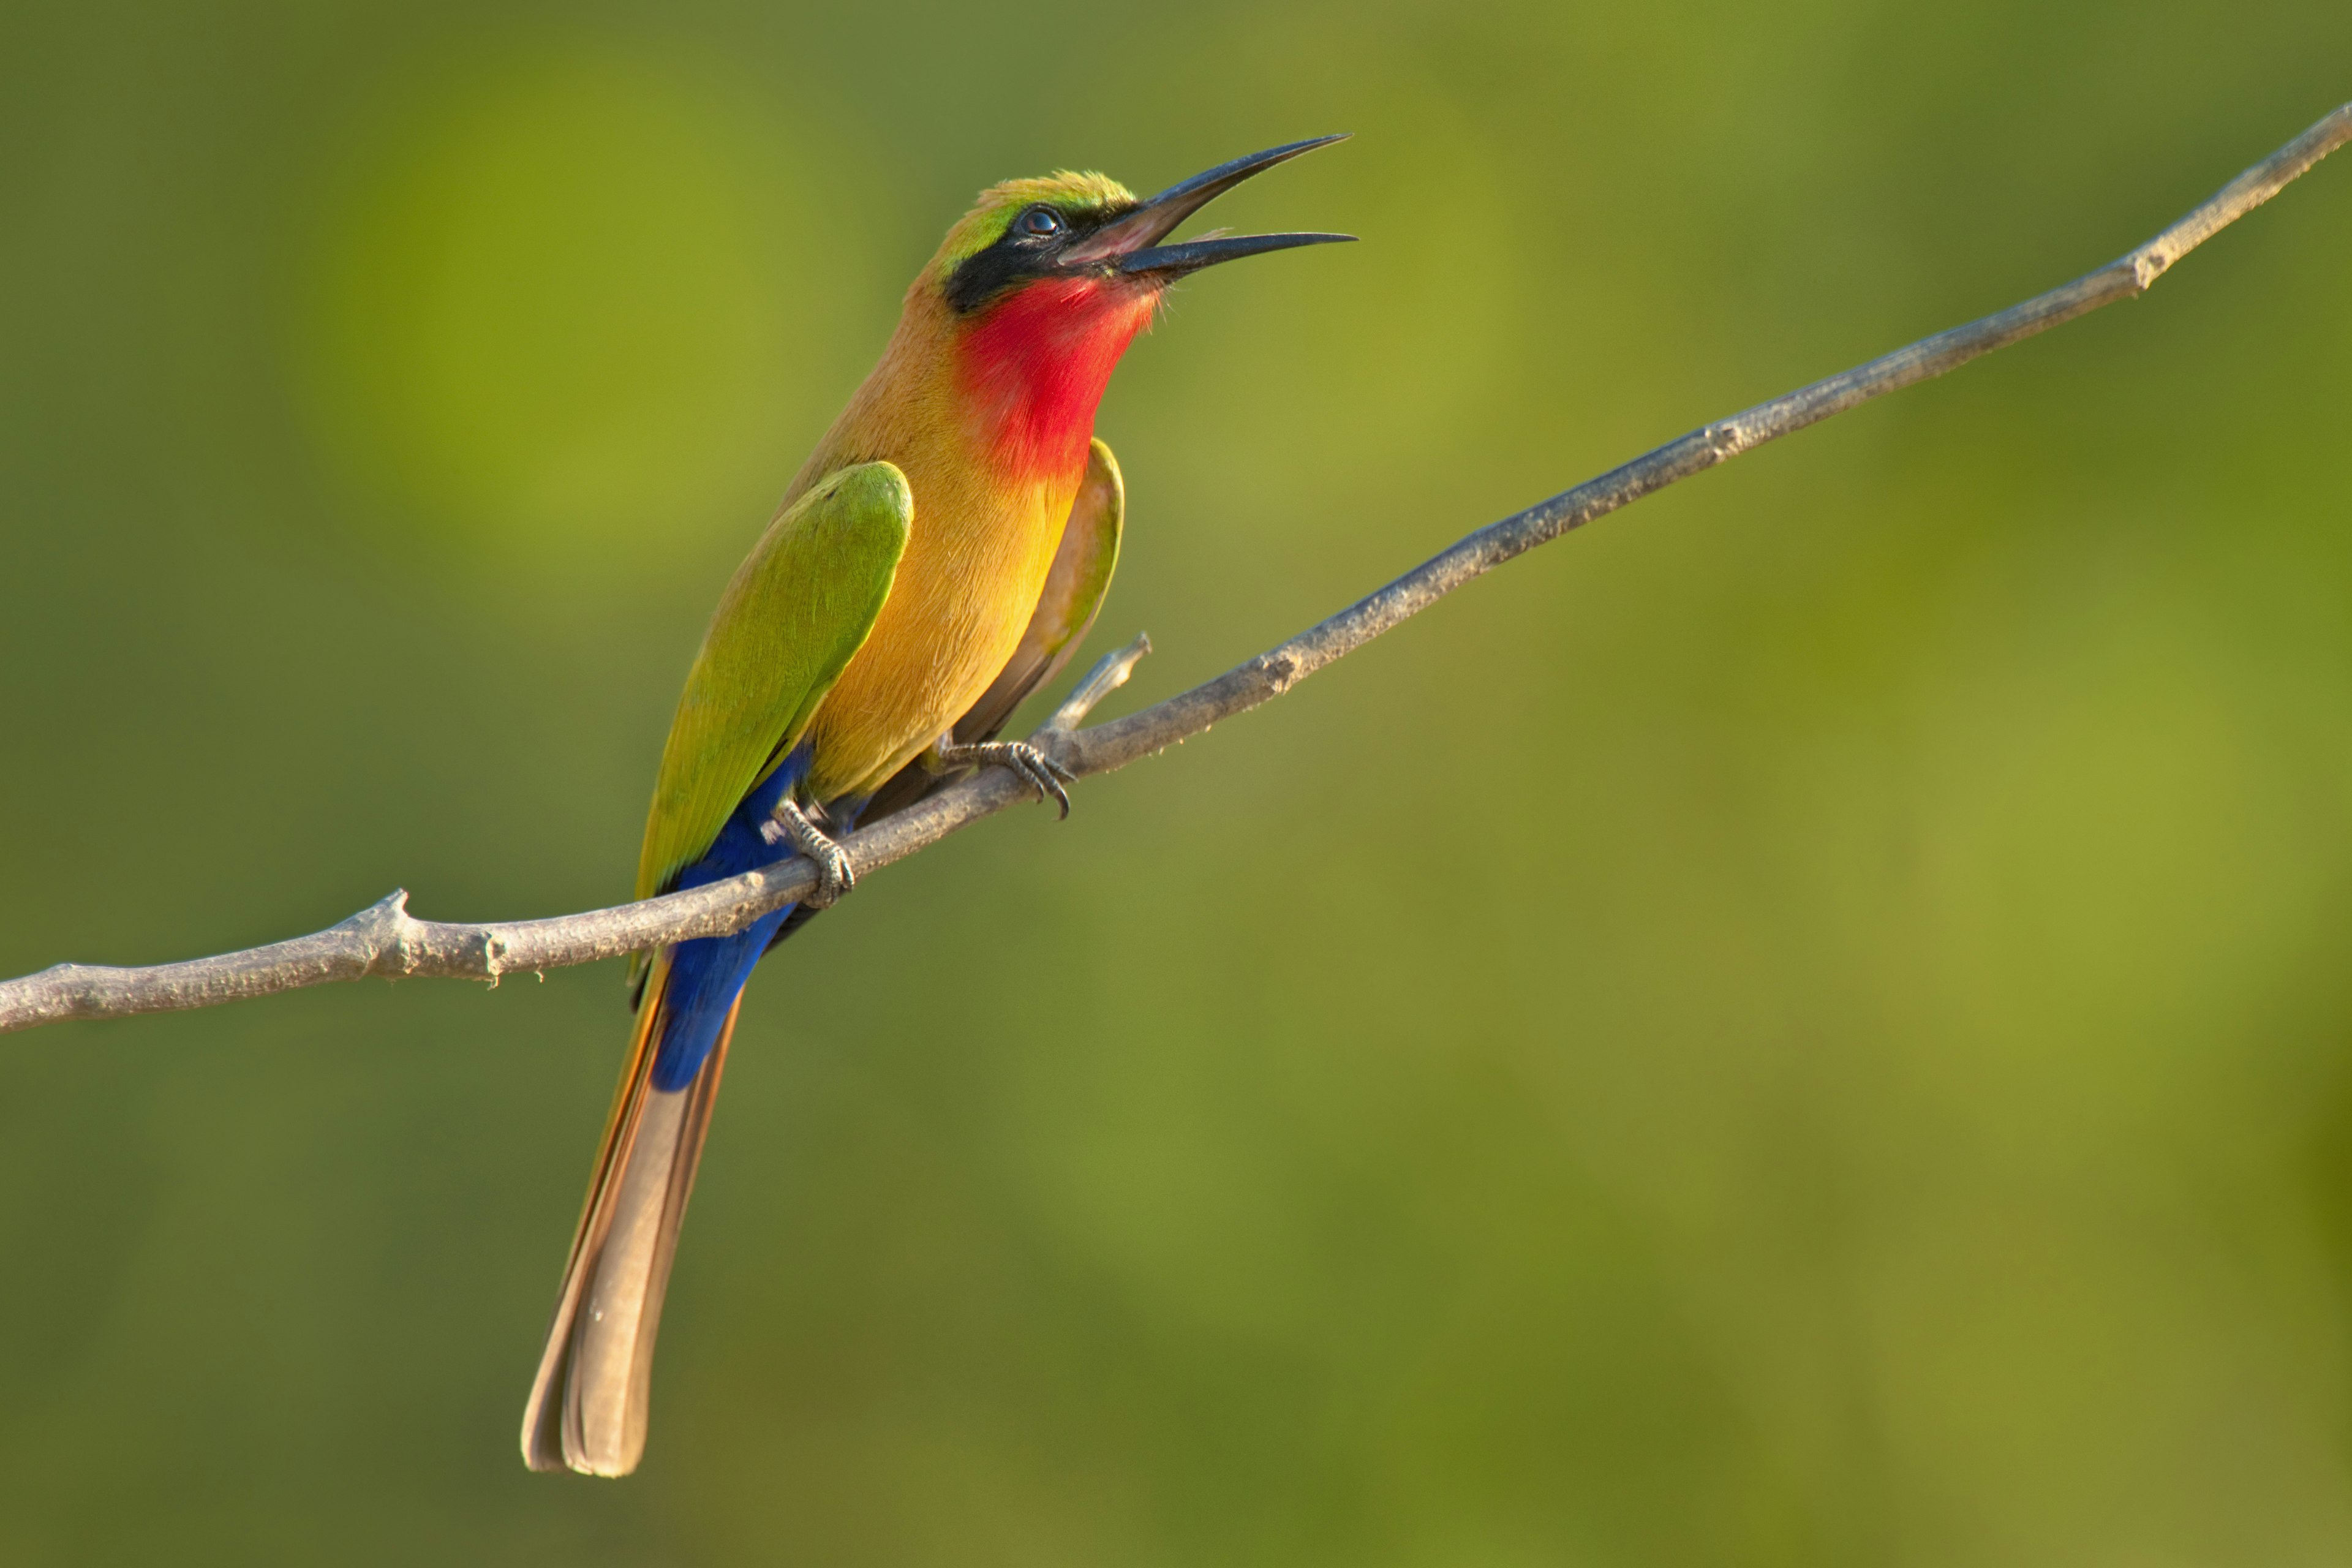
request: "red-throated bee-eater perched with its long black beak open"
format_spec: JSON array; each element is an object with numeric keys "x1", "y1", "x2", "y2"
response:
[{"x1": 522, "y1": 137, "x2": 1350, "y2": 1476}]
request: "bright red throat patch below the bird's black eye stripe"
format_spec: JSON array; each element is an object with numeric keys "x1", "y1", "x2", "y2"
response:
[{"x1": 962, "y1": 277, "x2": 1159, "y2": 480}]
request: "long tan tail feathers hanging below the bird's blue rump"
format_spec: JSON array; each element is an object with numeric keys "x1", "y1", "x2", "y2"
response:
[{"x1": 522, "y1": 964, "x2": 741, "y2": 1476}]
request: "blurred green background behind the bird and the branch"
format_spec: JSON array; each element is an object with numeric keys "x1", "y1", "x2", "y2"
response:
[{"x1": 0, "y1": 0, "x2": 2352, "y2": 1568}]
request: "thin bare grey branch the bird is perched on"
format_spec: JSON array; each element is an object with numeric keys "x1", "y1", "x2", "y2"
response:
[{"x1": 0, "y1": 104, "x2": 2352, "y2": 1032}]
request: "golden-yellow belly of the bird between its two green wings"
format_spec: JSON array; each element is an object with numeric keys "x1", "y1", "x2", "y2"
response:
[{"x1": 807, "y1": 463, "x2": 1082, "y2": 799}]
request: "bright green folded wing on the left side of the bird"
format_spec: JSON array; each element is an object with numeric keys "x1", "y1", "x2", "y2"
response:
[{"x1": 638, "y1": 463, "x2": 915, "y2": 898}]
